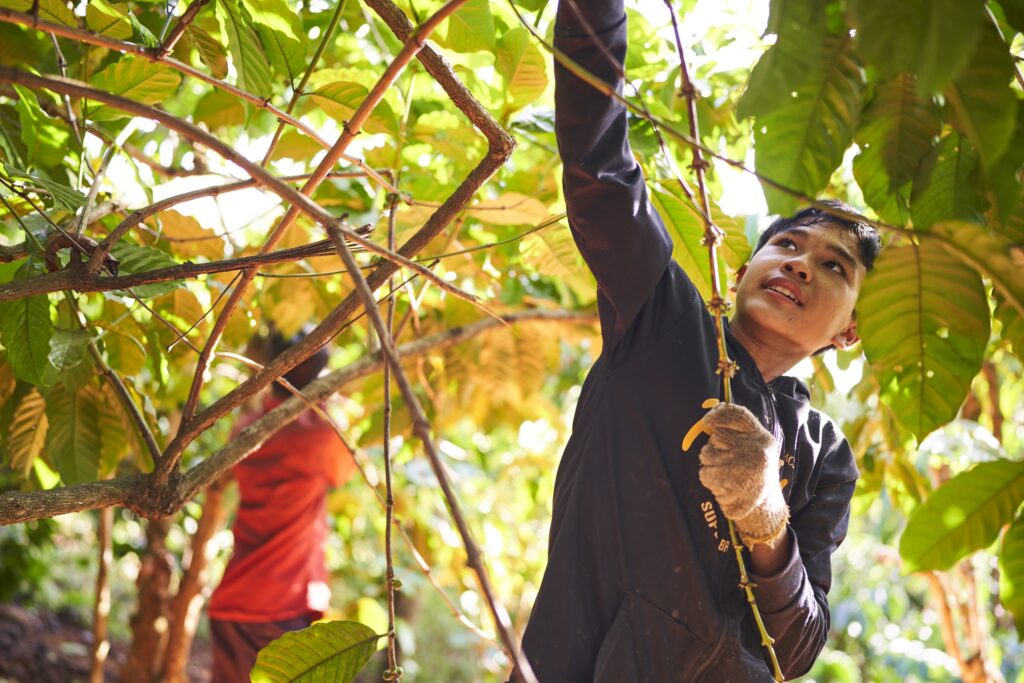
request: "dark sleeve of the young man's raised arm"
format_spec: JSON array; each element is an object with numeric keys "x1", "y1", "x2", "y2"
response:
[{"x1": 555, "y1": 0, "x2": 672, "y2": 345}]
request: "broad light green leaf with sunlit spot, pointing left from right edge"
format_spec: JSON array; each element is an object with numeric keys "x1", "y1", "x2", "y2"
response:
[{"x1": 899, "y1": 461, "x2": 1024, "y2": 572}]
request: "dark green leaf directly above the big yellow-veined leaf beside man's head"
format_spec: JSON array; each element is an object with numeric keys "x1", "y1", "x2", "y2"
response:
[{"x1": 910, "y1": 134, "x2": 982, "y2": 230}]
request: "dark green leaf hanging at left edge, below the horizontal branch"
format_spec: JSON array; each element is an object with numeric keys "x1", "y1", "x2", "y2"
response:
[{"x1": 0, "y1": 294, "x2": 53, "y2": 386}]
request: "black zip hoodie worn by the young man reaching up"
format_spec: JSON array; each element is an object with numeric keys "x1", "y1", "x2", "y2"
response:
[{"x1": 523, "y1": 0, "x2": 857, "y2": 683}]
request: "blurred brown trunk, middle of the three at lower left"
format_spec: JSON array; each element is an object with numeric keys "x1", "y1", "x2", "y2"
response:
[{"x1": 121, "y1": 517, "x2": 173, "y2": 683}]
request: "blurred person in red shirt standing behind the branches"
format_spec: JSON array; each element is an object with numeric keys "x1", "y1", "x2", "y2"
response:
[{"x1": 209, "y1": 334, "x2": 355, "y2": 683}]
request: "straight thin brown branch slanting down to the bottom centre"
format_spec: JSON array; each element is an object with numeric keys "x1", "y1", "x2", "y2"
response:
[{"x1": 328, "y1": 220, "x2": 537, "y2": 683}]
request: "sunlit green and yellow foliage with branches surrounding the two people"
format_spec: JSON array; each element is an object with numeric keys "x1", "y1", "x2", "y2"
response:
[{"x1": 0, "y1": 0, "x2": 1024, "y2": 681}]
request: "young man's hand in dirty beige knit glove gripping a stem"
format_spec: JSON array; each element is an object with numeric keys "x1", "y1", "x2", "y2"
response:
[{"x1": 700, "y1": 403, "x2": 790, "y2": 547}]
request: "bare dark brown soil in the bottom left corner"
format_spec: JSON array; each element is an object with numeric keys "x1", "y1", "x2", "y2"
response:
[{"x1": 0, "y1": 604, "x2": 212, "y2": 683}]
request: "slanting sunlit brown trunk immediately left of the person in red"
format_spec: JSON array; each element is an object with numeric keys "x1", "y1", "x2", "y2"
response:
[{"x1": 161, "y1": 478, "x2": 227, "y2": 683}]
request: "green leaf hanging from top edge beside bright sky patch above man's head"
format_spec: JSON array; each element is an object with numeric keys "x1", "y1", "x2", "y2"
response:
[{"x1": 737, "y1": 0, "x2": 825, "y2": 118}]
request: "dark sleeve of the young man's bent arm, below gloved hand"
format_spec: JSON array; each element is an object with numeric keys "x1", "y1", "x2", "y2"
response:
[{"x1": 751, "y1": 414, "x2": 858, "y2": 680}]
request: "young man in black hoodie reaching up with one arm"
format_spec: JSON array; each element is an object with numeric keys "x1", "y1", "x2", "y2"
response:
[{"x1": 523, "y1": 0, "x2": 880, "y2": 683}]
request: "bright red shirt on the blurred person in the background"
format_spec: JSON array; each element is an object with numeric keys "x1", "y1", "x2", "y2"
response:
[{"x1": 210, "y1": 397, "x2": 355, "y2": 623}]
